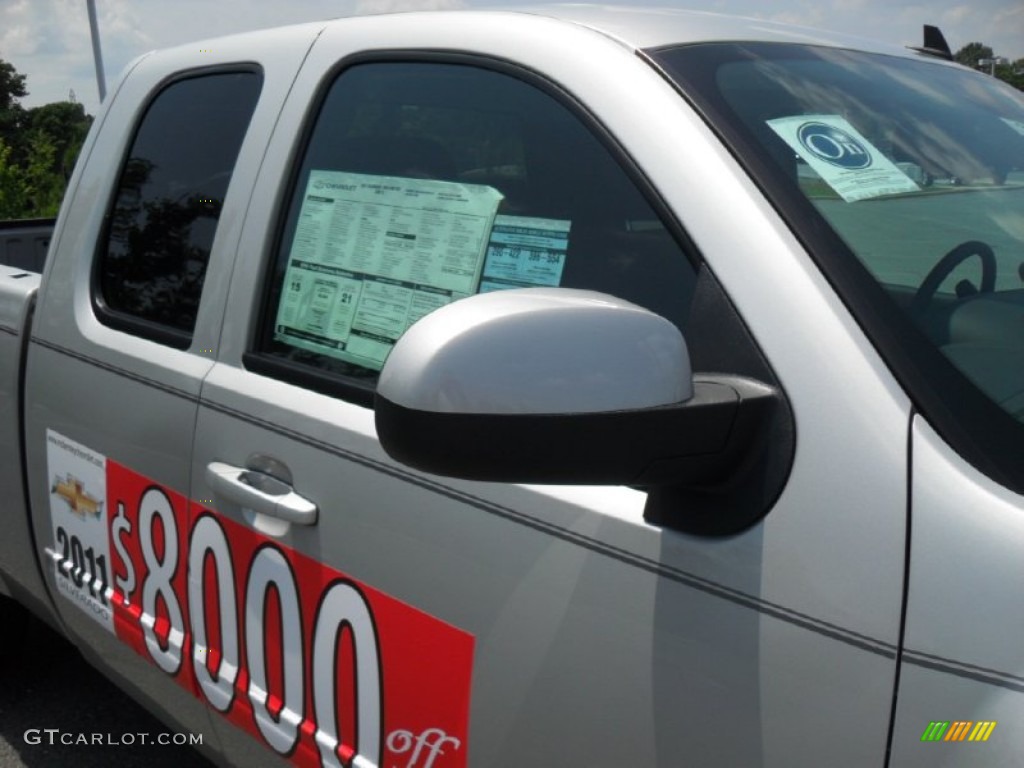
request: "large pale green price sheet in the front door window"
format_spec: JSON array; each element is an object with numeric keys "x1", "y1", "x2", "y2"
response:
[{"x1": 274, "y1": 170, "x2": 502, "y2": 371}]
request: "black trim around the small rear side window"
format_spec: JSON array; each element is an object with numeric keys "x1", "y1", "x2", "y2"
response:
[{"x1": 89, "y1": 61, "x2": 264, "y2": 349}]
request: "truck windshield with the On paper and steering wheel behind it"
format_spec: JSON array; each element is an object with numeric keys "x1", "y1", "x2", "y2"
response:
[{"x1": 650, "y1": 44, "x2": 1024, "y2": 487}]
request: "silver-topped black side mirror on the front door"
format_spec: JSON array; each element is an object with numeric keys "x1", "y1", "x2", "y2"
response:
[{"x1": 376, "y1": 288, "x2": 776, "y2": 485}]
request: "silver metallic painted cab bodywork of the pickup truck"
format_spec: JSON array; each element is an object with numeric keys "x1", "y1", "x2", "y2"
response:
[{"x1": 0, "y1": 8, "x2": 1024, "y2": 766}]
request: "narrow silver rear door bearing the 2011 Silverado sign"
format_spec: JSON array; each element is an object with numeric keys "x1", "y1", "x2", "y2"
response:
[{"x1": 26, "y1": 37, "x2": 296, "y2": 748}]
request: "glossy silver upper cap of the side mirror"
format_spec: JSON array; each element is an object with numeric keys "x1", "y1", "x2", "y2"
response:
[{"x1": 377, "y1": 288, "x2": 693, "y2": 414}]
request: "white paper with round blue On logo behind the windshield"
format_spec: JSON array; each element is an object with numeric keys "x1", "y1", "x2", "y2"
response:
[{"x1": 767, "y1": 115, "x2": 920, "y2": 203}]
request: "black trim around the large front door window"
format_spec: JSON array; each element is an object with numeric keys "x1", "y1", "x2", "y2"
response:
[{"x1": 242, "y1": 49, "x2": 703, "y2": 409}]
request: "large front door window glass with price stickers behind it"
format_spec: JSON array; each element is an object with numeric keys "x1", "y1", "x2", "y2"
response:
[{"x1": 262, "y1": 62, "x2": 694, "y2": 383}]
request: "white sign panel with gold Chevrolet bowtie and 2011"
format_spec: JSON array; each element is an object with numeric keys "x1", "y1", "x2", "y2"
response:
[{"x1": 46, "y1": 429, "x2": 114, "y2": 632}]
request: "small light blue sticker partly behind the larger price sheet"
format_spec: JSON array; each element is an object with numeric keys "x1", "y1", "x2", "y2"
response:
[{"x1": 480, "y1": 216, "x2": 571, "y2": 293}]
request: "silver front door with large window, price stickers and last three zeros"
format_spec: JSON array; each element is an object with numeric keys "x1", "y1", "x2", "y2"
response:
[{"x1": 188, "y1": 16, "x2": 908, "y2": 768}]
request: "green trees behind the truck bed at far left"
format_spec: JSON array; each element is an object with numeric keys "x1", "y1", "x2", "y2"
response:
[{"x1": 0, "y1": 58, "x2": 92, "y2": 219}]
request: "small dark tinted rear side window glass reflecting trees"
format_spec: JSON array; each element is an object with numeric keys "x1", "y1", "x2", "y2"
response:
[{"x1": 98, "y1": 72, "x2": 261, "y2": 335}]
